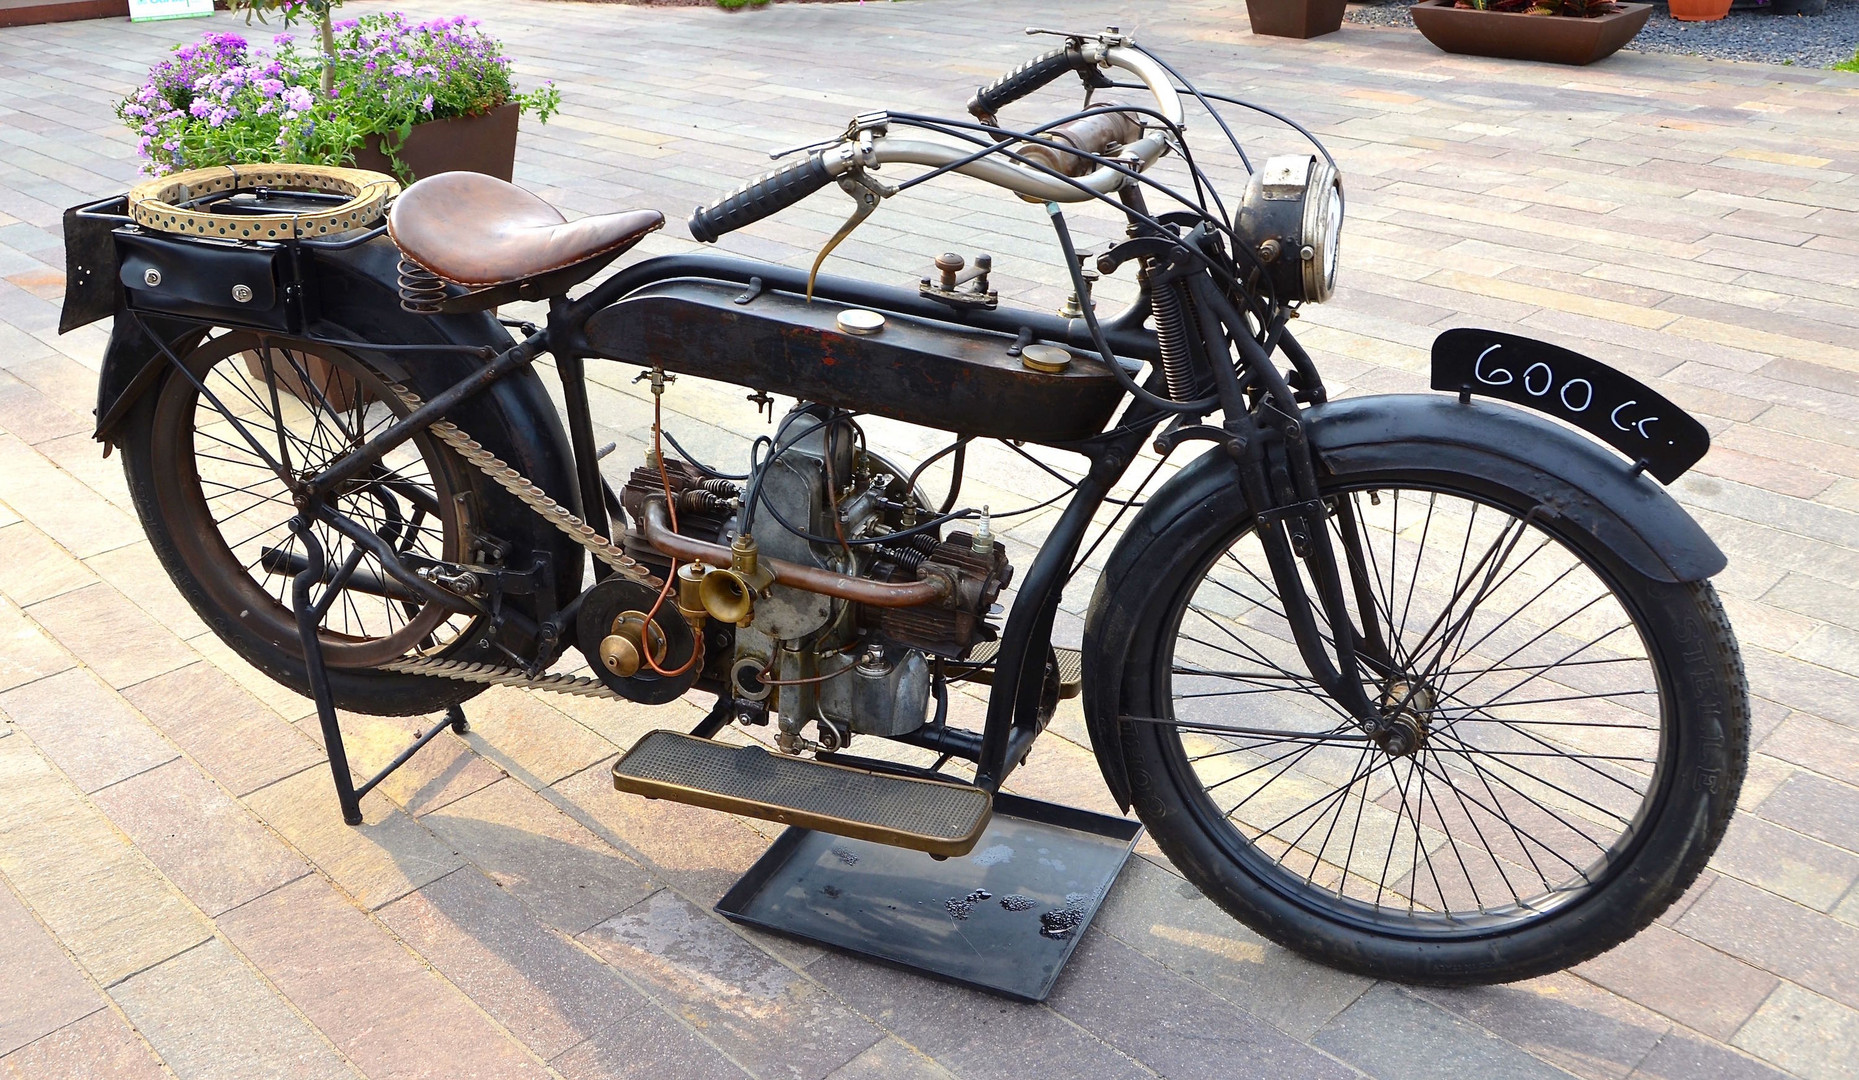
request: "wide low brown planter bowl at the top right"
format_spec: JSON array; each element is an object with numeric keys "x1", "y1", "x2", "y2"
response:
[{"x1": 1413, "y1": 0, "x2": 1658, "y2": 63}]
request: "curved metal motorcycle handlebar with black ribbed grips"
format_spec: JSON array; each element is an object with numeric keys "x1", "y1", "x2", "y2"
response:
[{"x1": 690, "y1": 41, "x2": 1182, "y2": 244}]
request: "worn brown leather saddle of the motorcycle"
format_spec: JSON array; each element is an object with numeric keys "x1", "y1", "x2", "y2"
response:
[{"x1": 387, "y1": 173, "x2": 666, "y2": 310}]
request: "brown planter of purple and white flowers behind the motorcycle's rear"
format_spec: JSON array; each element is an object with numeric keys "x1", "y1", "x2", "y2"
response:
[{"x1": 117, "y1": 0, "x2": 561, "y2": 182}]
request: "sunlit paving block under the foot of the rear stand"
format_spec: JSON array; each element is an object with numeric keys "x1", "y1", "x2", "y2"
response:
[{"x1": 245, "y1": 768, "x2": 465, "y2": 911}]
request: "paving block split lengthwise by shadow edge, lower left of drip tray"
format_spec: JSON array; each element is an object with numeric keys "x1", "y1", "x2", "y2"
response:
[{"x1": 379, "y1": 866, "x2": 653, "y2": 1058}]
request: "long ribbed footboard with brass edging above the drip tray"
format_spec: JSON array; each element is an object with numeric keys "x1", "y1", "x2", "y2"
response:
[{"x1": 613, "y1": 731, "x2": 995, "y2": 855}]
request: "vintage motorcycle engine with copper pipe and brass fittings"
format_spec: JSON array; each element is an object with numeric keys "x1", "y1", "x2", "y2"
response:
[{"x1": 621, "y1": 405, "x2": 1013, "y2": 751}]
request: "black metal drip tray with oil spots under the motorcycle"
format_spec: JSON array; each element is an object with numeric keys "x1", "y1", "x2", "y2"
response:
[{"x1": 716, "y1": 794, "x2": 1143, "y2": 1002}]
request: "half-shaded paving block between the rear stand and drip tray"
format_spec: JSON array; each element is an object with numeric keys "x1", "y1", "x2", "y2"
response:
[{"x1": 424, "y1": 779, "x2": 662, "y2": 935}]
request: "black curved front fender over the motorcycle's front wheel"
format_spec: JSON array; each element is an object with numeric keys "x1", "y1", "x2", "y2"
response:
[{"x1": 1084, "y1": 394, "x2": 1727, "y2": 807}]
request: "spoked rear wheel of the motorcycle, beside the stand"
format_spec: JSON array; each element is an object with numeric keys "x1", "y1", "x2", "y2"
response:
[{"x1": 123, "y1": 333, "x2": 481, "y2": 716}]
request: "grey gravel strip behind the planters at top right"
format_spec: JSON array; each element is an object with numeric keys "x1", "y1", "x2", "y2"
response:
[{"x1": 1344, "y1": 0, "x2": 1859, "y2": 67}]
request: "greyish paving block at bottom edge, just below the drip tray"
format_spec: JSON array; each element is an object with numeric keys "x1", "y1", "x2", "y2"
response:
[{"x1": 807, "y1": 952, "x2": 1153, "y2": 1080}]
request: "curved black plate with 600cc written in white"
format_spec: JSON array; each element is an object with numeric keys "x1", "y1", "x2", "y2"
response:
[{"x1": 1433, "y1": 327, "x2": 1710, "y2": 483}]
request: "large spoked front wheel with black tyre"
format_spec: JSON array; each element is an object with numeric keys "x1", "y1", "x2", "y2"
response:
[{"x1": 1117, "y1": 459, "x2": 1749, "y2": 983}]
